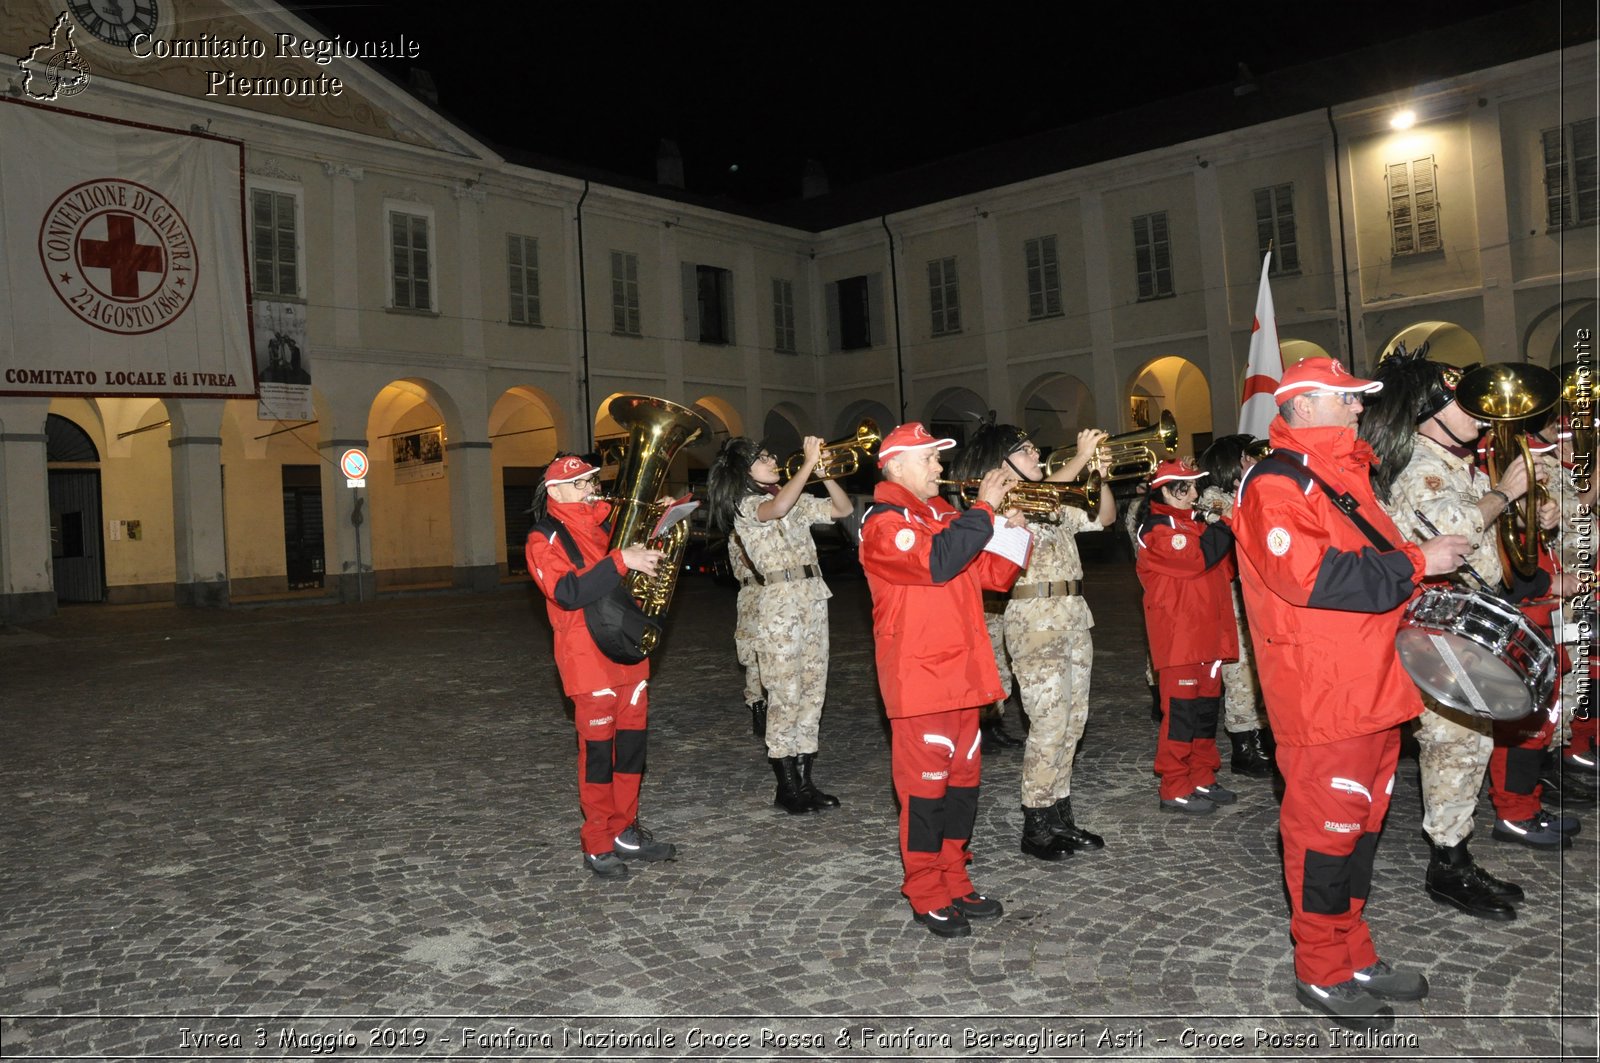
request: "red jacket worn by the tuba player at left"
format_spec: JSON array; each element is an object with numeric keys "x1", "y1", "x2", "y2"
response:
[{"x1": 525, "y1": 503, "x2": 650, "y2": 695}]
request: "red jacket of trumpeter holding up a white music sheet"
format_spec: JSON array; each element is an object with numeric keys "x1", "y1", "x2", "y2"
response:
[{"x1": 861, "y1": 482, "x2": 1022, "y2": 717}]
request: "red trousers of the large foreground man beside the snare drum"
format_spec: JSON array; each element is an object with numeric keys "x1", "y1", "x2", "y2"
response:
[{"x1": 1275, "y1": 727, "x2": 1400, "y2": 986}]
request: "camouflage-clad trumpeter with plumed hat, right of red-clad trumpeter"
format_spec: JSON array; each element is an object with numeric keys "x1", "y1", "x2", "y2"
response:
[{"x1": 954, "y1": 424, "x2": 1117, "y2": 860}]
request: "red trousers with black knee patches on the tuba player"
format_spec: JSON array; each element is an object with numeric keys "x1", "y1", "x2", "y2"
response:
[{"x1": 573, "y1": 680, "x2": 650, "y2": 855}]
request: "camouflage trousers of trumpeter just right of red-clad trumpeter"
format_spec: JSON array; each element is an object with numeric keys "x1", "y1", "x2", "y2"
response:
[{"x1": 1005, "y1": 599, "x2": 1094, "y2": 808}]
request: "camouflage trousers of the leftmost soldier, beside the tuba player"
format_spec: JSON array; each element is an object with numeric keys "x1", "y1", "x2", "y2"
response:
[{"x1": 755, "y1": 584, "x2": 827, "y2": 757}]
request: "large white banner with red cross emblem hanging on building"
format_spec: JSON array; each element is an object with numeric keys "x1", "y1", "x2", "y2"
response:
[{"x1": 0, "y1": 99, "x2": 256, "y2": 397}]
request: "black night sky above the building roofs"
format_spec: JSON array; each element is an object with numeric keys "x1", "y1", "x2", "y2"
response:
[{"x1": 288, "y1": 0, "x2": 1558, "y2": 203}]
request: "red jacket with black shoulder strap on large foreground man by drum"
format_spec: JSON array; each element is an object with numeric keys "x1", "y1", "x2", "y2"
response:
[{"x1": 1234, "y1": 418, "x2": 1426, "y2": 746}]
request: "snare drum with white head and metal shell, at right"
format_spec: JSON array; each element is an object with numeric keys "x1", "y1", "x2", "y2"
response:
[{"x1": 1395, "y1": 588, "x2": 1555, "y2": 720}]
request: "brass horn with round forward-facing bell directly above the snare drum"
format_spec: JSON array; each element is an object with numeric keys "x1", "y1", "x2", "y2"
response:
[{"x1": 1456, "y1": 362, "x2": 1562, "y2": 583}]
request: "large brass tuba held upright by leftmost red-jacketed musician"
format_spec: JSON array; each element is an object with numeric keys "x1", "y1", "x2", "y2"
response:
[{"x1": 606, "y1": 395, "x2": 707, "y2": 653}]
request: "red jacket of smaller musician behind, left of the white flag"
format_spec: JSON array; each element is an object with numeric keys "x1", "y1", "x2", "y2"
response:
[{"x1": 1134, "y1": 501, "x2": 1238, "y2": 669}]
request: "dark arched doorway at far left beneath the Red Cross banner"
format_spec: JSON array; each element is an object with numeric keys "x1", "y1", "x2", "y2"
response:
[{"x1": 45, "y1": 413, "x2": 106, "y2": 602}]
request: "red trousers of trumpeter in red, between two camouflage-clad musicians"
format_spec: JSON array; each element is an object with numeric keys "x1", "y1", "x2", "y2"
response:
[{"x1": 890, "y1": 706, "x2": 984, "y2": 913}]
